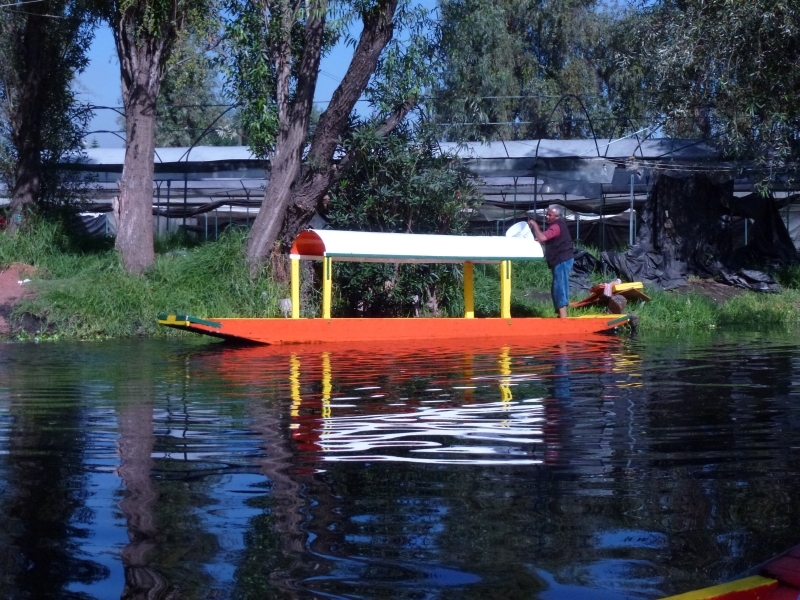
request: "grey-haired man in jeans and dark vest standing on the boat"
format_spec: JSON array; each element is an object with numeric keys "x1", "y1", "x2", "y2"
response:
[{"x1": 528, "y1": 204, "x2": 575, "y2": 319}]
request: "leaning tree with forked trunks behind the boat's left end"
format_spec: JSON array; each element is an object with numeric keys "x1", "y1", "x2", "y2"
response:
[{"x1": 222, "y1": 0, "x2": 434, "y2": 275}]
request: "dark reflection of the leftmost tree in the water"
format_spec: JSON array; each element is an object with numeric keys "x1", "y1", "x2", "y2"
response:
[{"x1": 0, "y1": 344, "x2": 108, "y2": 598}]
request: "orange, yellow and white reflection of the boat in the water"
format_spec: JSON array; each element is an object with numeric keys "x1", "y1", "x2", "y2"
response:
[{"x1": 200, "y1": 336, "x2": 619, "y2": 468}]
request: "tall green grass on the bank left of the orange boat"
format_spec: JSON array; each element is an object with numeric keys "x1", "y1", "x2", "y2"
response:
[{"x1": 0, "y1": 222, "x2": 286, "y2": 338}]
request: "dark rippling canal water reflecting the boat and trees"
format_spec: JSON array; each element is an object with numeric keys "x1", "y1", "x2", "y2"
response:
[{"x1": 0, "y1": 331, "x2": 800, "y2": 600}]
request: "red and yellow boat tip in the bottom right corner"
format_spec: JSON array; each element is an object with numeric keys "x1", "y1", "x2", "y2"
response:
[{"x1": 663, "y1": 546, "x2": 800, "y2": 600}]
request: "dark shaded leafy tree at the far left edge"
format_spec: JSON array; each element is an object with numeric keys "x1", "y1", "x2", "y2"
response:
[{"x1": 0, "y1": 0, "x2": 96, "y2": 234}]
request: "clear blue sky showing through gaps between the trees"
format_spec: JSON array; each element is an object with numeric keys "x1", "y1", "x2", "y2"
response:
[{"x1": 75, "y1": 26, "x2": 368, "y2": 148}]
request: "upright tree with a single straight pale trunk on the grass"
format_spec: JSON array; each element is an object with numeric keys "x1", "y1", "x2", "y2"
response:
[{"x1": 109, "y1": 0, "x2": 214, "y2": 273}]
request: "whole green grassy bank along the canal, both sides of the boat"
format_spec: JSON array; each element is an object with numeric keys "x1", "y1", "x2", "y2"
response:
[{"x1": 0, "y1": 222, "x2": 800, "y2": 339}]
